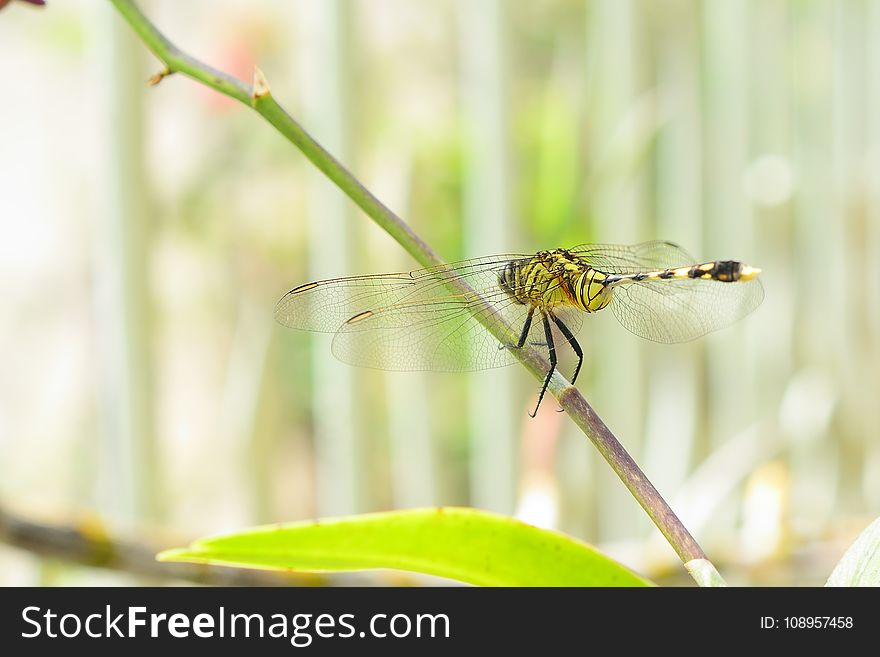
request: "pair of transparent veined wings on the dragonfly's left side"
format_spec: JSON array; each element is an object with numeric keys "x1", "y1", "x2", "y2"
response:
[{"x1": 275, "y1": 255, "x2": 582, "y2": 371}]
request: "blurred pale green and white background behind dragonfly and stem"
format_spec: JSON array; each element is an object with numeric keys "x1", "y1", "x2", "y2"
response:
[{"x1": 0, "y1": 0, "x2": 880, "y2": 585}]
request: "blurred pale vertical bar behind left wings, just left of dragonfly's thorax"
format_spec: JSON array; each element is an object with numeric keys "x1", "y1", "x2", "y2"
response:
[{"x1": 458, "y1": 0, "x2": 516, "y2": 514}]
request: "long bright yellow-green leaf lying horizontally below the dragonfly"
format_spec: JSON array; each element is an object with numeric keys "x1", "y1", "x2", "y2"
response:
[{"x1": 158, "y1": 508, "x2": 651, "y2": 586}]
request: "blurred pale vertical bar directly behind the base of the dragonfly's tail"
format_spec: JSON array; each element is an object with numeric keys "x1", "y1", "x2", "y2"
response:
[{"x1": 584, "y1": 0, "x2": 653, "y2": 541}]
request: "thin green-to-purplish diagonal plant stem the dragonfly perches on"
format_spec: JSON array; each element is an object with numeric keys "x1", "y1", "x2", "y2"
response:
[{"x1": 110, "y1": 0, "x2": 720, "y2": 580}]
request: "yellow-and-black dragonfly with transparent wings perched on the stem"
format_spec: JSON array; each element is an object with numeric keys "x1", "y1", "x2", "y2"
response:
[{"x1": 275, "y1": 241, "x2": 764, "y2": 417}]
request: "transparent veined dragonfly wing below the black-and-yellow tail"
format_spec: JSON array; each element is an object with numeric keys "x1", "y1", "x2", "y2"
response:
[{"x1": 611, "y1": 278, "x2": 764, "y2": 343}]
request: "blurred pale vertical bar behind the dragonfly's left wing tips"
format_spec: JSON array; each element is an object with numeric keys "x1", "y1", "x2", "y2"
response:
[{"x1": 299, "y1": 0, "x2": 365, "y2": 516}]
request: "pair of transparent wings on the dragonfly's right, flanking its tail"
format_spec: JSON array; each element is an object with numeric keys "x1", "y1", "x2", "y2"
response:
[{"x1": 575, "y1": 241, "x2": 764, "y2": 343}]
